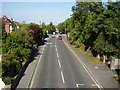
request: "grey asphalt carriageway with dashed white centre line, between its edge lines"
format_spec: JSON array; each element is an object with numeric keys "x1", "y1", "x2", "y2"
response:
[{"x1": 30, "y1": 38, "x2": 98, "y2": 88}]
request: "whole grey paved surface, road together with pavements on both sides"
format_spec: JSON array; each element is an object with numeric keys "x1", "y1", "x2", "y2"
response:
[{"x1": 17, "y1": 37, "x2": 118, "y2": 90}]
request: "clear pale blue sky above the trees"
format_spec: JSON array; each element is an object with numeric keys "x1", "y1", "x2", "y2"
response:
[{"x1": 0, "y1": 0, "x2": 117, "y2": 25}]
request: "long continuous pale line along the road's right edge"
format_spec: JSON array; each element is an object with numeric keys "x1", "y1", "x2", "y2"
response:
[{"x1": 63, "y1": 40, "x2": 104, "y2": 90}]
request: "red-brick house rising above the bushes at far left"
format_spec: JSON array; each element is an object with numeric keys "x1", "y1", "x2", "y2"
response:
[{"x1": 1, "y1": 16, "x2": 16, "y2": 34}]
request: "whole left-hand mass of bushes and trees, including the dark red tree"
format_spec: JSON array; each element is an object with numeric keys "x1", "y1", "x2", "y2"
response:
[{"x1": 0, "y1": 19, "x2": 47, "y2": 84}]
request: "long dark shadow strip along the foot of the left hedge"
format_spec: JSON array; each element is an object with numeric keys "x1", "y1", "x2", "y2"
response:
[{"x1": 11, "y1": 40, "x2": 47, "y2": 90}]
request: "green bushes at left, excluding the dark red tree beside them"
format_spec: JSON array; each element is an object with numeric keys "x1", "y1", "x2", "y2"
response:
[{"x1": 2, "y1": 24, "x2": 34, "y2": 84}]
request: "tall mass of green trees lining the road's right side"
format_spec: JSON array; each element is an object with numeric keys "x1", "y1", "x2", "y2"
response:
[{"x1": 57, "y1": 2, "x2": 120, "y2": 58}]
